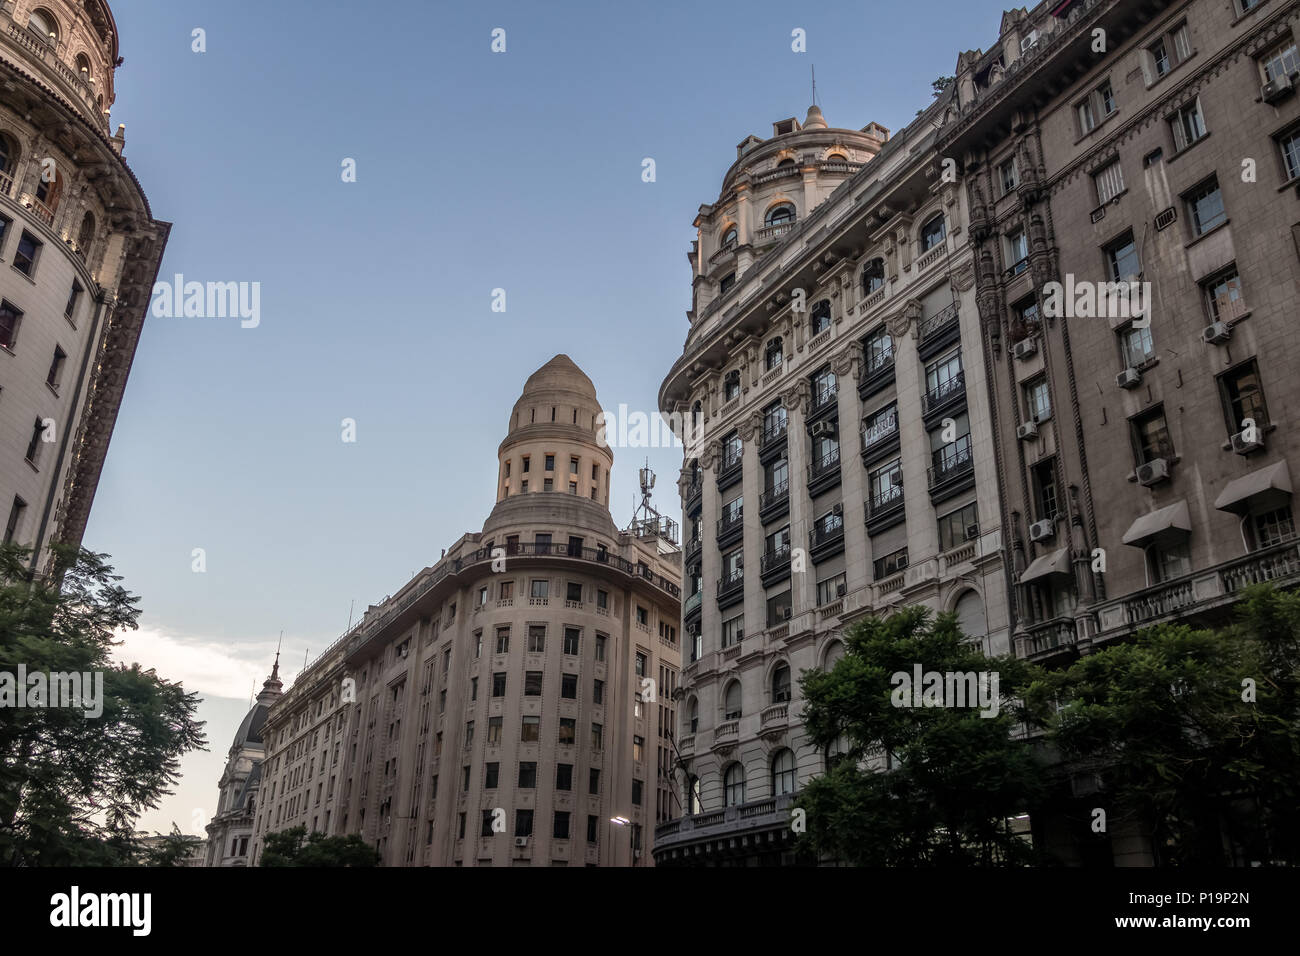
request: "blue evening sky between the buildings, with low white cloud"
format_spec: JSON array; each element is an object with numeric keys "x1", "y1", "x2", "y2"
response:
[{"x1": 94, "y1": 0, "x2": 1002, "y2": 832}]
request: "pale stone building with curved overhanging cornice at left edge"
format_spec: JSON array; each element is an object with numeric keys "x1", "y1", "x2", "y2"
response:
[{"x1": 0, "y1": 0, "x2": 170, "y2": 570}]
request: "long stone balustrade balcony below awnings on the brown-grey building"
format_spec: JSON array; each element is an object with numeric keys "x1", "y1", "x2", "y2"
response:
[{"x1": 1097, "y1": 541, "x2": 1300, "y2": 639}]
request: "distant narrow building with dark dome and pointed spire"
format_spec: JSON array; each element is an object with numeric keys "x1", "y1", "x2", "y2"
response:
[{"x1": 207, "y1": 653, "x2": 285, "y2": 866}]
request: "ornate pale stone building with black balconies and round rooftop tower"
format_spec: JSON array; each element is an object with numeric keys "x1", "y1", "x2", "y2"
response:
[{"x1": 655, "y1": 106, "x2": 1010, "y2": 865}]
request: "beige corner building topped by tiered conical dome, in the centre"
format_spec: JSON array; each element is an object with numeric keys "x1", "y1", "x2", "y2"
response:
[{"x1": 254, "y1": 355, "x2": 681, "y2": 866}]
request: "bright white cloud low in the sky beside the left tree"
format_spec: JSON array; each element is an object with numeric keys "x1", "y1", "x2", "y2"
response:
[{"x1": 113, "y1": 626, "x2": 276, "y2": 700}]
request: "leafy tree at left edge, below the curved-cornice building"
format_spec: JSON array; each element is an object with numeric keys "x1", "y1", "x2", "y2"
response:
[{"x1": 0, "y1": 545, "x2": 207, "y2": 866}]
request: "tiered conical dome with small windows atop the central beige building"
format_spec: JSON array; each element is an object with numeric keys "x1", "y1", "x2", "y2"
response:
[{"x1": 497, "y1": 355, "x2": 614, "y2": 511}]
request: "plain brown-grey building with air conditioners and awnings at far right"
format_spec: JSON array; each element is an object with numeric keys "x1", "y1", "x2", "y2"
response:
[{"x1": 940, "y1": 0, "x2": 1300, "y2": 864}]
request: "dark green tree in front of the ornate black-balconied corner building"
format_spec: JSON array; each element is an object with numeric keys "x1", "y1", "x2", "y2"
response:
[{"x1": 797, "y1": 607, "x2": 1044, "y2": 866}]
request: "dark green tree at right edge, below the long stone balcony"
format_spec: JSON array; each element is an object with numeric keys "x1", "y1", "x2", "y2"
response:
[{"x1": 1031, "y1": 585, "x2": 1300, "y2": 866}]
